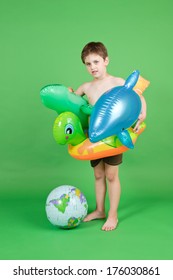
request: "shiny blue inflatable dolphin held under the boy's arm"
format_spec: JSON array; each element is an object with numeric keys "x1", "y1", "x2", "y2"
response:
[{"x1": 89, "y1": 70, "x2": 141, "y2": 149}]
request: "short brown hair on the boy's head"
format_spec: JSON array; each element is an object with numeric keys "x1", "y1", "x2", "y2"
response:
[{"x1": 81, "y1": 42, "x2": 108, "y2": 63}]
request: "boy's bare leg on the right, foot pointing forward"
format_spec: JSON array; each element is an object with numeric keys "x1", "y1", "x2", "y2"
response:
[{"x1": 102, "y1": 163, "x2": 121, "y2": 231}]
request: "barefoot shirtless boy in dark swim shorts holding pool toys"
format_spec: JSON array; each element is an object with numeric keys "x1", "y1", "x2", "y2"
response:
[{"x1": 75, "y1": 42, "x2": 146, "y2": 231}]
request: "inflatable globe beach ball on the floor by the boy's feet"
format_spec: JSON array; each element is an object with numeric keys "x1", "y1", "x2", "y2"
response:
[{"x1": 46, "y1": 185, "x2": 88, "y2": 229}]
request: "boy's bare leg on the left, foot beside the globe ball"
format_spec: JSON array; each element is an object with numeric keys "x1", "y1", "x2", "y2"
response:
[{"x1": 84, "y1": 160, "x2": 106, "y2": 222}]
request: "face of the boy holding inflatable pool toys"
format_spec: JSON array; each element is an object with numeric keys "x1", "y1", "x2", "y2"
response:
[{"x1": 85, "y1": 53, "x2": 109, "y2": 79}]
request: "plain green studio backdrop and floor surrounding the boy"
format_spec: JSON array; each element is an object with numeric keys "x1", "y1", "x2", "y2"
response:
[{"x1": 0, "y1": 0, "x2": 173, "y2": 260}]
